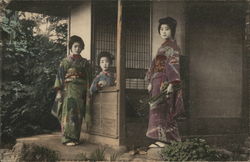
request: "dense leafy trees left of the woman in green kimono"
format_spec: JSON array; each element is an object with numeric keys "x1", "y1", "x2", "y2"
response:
[{"x1": 0, "y1": 1, "x2": 67, "y2": 143}]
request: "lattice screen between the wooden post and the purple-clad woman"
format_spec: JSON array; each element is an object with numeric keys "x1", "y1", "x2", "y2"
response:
[{"x1": 124, "y1": 2, "x2": 151, "y2": 89}]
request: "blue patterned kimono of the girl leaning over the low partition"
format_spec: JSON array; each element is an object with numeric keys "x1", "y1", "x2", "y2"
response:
[{"x1": 90, "y1": 71, "x2": 115, "y2": 95}]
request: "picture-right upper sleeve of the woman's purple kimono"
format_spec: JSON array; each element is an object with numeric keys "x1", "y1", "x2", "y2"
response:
[{"x1": 166, "y1": 49, "x2": 181, "y2": 84}]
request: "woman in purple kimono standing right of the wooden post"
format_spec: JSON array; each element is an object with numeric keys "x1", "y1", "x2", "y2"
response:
[{"x1": 146, "y1": 17, "x2": 184, "y2": 147}]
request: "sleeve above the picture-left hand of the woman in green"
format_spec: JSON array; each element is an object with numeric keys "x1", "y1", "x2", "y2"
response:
[{"x1": 54, "y1": 61, "x2": 65, "y2": 90}]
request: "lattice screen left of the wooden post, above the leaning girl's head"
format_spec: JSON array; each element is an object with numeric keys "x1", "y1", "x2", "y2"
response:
[{"x1": 91, "y1": 1, "x2": 117, "y2": 70}]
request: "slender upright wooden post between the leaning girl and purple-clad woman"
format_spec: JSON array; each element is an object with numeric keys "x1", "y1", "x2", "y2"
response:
[{"x1": 116, "y1": 0, "x2": 125, "y2": 145}]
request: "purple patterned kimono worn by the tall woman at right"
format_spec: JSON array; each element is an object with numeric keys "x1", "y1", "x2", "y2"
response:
[{"x1": 146, "y1": 40, "x2": 184, "y2": 142}]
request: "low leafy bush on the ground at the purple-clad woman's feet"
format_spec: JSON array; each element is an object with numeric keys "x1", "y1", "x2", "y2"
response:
[{"x1": 161, "y1": 138, "x2": 229, "y2": 161}]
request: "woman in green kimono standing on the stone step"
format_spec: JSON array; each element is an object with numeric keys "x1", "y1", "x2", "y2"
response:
[{"x1": 52, "y1": 36, "x2": 91, "y2": 146}]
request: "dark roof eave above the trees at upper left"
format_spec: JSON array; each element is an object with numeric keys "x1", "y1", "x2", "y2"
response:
[{"x1": 6, "y1": 0, "x2": 90, "y2": 17}]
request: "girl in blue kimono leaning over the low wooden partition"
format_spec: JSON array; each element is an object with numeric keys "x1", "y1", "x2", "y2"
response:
[{"x1": 90, "y1": 52, "x2": 115, "y2": 96}]
